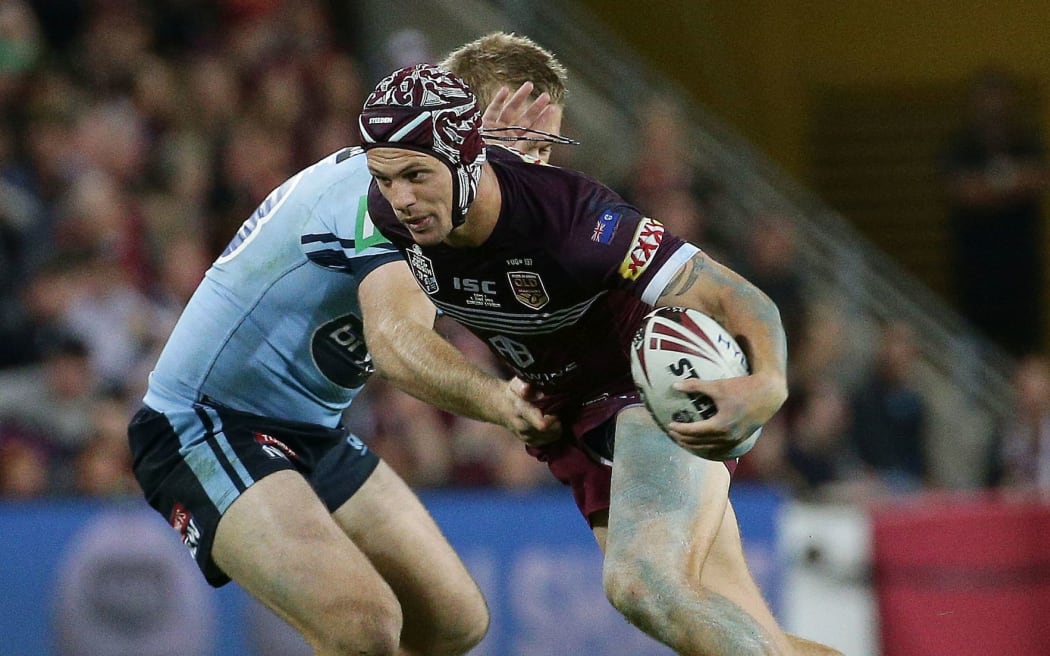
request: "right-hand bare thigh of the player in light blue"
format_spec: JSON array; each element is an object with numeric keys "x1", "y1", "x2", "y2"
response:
[{"x1": 334, "y1": 462, "x2": 488, "y2": 641}]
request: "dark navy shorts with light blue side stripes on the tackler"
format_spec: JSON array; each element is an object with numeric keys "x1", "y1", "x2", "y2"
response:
[{"x1": 128, "y1": 403, "x2": 379, "y2": 588}]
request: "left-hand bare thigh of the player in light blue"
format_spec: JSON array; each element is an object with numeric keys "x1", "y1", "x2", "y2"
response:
[{"x1": 212, "y1": 470, "x2": 400, "y2": 637}]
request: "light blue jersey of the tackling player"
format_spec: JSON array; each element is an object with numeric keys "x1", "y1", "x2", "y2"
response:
[{"x1": 144, "y1": 148, "x2": 401, "y2": 427}]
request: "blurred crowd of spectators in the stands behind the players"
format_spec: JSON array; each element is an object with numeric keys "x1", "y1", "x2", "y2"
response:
[{"x1": 0, "y1": 0, "x2": 1050, "y2": 500}]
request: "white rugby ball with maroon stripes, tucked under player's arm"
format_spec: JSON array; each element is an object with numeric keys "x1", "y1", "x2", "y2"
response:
[{"x1": 631, "y1": 308, "x2": 762, "y2": 460}]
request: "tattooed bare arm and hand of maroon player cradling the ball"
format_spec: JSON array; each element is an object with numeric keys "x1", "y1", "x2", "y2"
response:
[{"x1": 655, "y1": 251, "x2": 788, "y2": 447}]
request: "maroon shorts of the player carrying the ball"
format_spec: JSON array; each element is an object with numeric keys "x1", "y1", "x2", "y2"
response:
[{"x1": 527, "y1": 393, "x2": 736, "y2": 524}]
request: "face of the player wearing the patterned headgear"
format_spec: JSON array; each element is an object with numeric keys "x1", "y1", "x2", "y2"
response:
[{"x1": 366, "y1": 148, "x2": 453, "y2": 246}]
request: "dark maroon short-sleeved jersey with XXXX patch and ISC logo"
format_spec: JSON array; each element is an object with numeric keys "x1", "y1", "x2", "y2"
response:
[{"x1": 369, "y1": 147, "x2": 697, "y2": 430}]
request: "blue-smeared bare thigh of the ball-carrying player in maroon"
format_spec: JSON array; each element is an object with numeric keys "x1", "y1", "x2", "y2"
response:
[{"x1": 609, "y1": 407, "x2": 730, "y2": 575}]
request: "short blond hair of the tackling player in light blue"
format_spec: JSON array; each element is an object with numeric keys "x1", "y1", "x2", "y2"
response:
[{"x1": 440, "y1": 31, "x2": 568, "y2": 107}]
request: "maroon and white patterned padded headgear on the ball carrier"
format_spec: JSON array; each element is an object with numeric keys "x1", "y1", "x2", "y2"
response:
[{"x1": 358, "y1": 64, "x2": 485, "y2": 227}]
